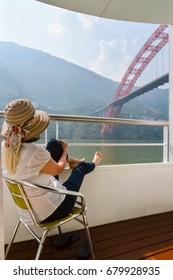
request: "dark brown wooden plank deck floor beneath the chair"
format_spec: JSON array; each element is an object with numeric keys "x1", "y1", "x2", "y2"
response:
[{"x1": 5, "y1": 211, "x2": 173, "y2": 260}]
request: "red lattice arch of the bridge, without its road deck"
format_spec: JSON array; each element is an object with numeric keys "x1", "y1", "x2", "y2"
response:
[{"x1": 101, "y1": 24, "x2": 168, "y2": 133}]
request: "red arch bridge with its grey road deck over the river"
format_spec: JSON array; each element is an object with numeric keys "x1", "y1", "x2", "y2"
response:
[{"x1": 94, "y1": 24, "x2": 169, "y2": 133}]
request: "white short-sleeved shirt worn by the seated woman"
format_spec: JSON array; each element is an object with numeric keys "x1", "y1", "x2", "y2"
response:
[{"x1": 1, "y1": 141, "x2": 66, "y2": 222}]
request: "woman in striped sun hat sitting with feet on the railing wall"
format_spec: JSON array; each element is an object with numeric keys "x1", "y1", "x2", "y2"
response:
[{"x1": 1, "y1": 99, "x2": 102, "y2": 221}]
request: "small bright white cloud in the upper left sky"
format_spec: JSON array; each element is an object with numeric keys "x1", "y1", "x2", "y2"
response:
[{"x1": 47, "y1": 22, "x2": 68, "y2": 39}]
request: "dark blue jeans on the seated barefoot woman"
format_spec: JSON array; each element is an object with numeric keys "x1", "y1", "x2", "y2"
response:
[{"x1": 44, "y1": 138, "x2": 95, "y2": 221}]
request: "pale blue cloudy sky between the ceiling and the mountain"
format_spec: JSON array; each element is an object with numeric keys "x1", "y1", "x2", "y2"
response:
[{"x1": 0, "y1": 0, "x2": 167, "y2": 82}]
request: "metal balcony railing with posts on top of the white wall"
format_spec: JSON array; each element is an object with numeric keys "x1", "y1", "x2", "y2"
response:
[{"x1": 0, "y1": 111, "x2": 168, "y2": 162}]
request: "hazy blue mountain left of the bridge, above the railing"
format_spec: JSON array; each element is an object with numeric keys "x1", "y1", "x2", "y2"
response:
[{"x1": 0, "y1": 42, "x2": 118, "y2": 115}]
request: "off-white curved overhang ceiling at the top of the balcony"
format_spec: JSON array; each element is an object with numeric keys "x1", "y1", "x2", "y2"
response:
[{"x1": 37, "y1": 0, "x2": 173, "y2": 24}]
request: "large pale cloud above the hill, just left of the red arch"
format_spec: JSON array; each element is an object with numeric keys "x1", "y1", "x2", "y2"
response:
[{"x1": 89, "y1": 36, "x2": 132, "y2": 82}]
